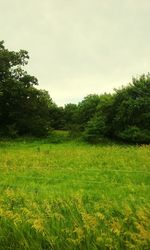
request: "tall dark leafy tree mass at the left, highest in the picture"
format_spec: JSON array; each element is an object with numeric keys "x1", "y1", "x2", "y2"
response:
[{"x1": 0, "y1": 41, "x2": 52, "y2": 136}]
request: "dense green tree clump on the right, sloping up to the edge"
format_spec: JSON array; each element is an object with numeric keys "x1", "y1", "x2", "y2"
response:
[{"x1": 84, "y1": 74, "x2": 150, "y2": 143}]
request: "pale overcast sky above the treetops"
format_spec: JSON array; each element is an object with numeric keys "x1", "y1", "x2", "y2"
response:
[{"x1": 0, "y1": 0, "x2": 150, "y2": 106}]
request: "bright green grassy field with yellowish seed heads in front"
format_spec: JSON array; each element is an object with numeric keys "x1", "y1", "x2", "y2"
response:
[{"x1": 0, "y1": 133, "x2": 150, "y2": 250}]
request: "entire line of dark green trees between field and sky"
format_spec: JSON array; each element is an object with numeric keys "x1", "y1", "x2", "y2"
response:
[{"x1": 0, "y1": 41, "x2": 150, "y2": 143}]
